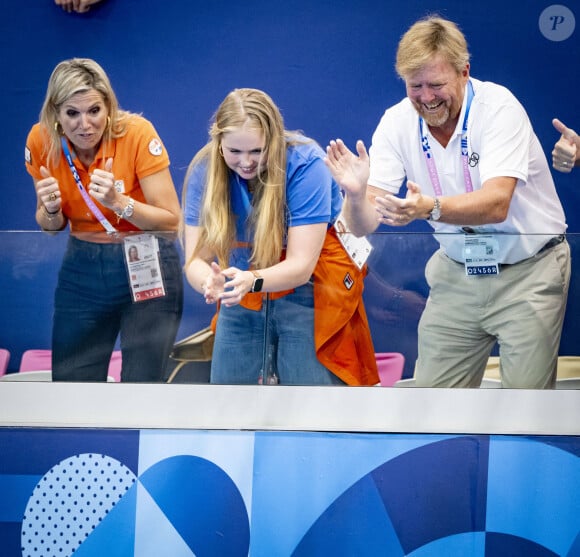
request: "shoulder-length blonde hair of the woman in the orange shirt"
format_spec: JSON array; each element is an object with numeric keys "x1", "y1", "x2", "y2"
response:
[{"x1": 40, "y1": 58, "x2": 131, "y2": 165}]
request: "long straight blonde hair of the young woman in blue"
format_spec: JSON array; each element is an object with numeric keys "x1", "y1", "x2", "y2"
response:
[{"x1": 183, "y1": 89, "x2": 297, "y2": 268}]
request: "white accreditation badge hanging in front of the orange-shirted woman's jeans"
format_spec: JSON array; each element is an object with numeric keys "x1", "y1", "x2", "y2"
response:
[{"x1": 124, "y1": 234, "x2": 165, "y2": 302}]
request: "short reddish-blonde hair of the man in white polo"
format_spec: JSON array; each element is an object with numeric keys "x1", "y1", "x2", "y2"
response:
[{"x1": 395, "y1": 16, "x2": 469, "y2": 79}]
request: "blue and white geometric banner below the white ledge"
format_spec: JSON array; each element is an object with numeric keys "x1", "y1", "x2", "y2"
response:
[{"x1": 0, "y1": 429, "x2": 580, "y2": 557}]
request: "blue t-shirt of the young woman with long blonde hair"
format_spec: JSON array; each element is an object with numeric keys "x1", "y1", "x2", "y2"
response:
[{"x1": 184, "y1": 137, "x2": 342, "y2": 268}]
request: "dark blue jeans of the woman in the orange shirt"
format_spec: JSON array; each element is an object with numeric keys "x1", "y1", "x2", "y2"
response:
[{"x1": 52, "y1": 232, "x2": 183, "y2": 382}]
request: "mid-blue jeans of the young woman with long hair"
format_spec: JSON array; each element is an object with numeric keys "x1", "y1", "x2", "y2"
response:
[{"x1": 211, "y1": 284, "x2": 344, "y2": 385}]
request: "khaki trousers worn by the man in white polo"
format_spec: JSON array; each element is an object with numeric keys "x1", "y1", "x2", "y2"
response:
[{"x1": 415, "y1": 241, "x2": 570, "y2": 389}]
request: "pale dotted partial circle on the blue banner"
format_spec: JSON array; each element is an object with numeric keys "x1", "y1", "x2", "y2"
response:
[{"x1": 21, "y1": 453, "x2": 136, "y2": 557}]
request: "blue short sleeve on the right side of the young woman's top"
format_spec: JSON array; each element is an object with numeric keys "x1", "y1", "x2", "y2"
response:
[{"x1": 286, "y1": 146, "x2": 341, "y2": 227}]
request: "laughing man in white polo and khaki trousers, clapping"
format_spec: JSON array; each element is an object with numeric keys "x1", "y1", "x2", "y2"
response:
[{"x1": 326, "y1": 17, "x2": 570, "y2": 388}]
